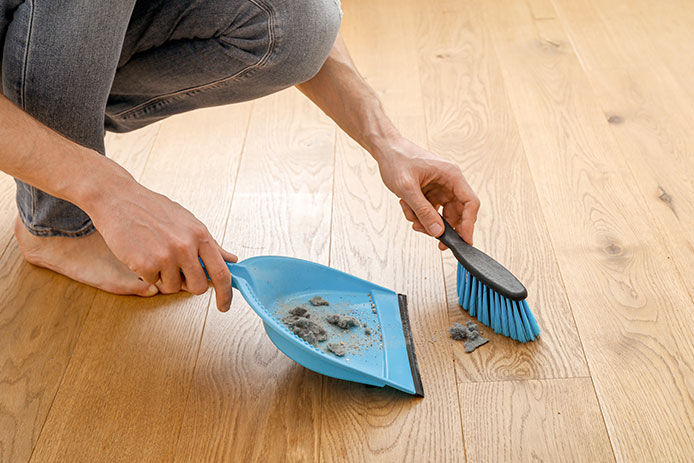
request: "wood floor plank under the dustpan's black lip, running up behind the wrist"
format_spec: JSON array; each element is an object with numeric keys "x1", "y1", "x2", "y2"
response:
[{"x1": 321, "y1": 1, "x2": 465, "y2": 461}]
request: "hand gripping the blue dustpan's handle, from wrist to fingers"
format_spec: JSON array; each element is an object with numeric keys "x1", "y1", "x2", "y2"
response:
[{"x1": 84, "y1": 170, "x2": 238, "y2": 312}]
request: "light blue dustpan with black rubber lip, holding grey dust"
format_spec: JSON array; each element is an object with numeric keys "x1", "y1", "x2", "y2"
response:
[{"x1": 220, "y1": 256, "x2": 424, "y2": 396}]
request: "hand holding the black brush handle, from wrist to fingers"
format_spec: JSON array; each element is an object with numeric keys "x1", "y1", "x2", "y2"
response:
[{"x1": 378, "y1": 139, "x2": 480, "y2": 250}]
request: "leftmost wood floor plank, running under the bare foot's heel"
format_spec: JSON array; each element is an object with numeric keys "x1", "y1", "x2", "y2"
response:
[{"x1": 0, "y1": 125, "x2": 158, "y2": 462}]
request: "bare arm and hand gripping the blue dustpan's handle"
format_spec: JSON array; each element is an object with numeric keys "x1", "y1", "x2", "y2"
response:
[{"x1": 0, "y1": 95, "x2": 236, "y2": 310}]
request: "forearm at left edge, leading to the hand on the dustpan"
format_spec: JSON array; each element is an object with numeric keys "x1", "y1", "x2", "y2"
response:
[{"x1": 0, "y1": 95, "x2": 132, "y2": 214}]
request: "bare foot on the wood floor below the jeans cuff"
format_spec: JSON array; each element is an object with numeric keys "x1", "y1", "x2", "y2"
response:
[{"x1": 14, "y1": 218, "x2": 158, "y2": 296}]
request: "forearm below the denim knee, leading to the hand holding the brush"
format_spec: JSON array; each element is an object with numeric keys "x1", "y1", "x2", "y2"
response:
[{"x1": 297, "y1": 35, "x2": 400, "y2": 161}]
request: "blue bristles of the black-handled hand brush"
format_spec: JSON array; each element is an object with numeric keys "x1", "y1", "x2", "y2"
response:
[{"x1": 457, "y1": 264, "x2": 540, "y2": 343}]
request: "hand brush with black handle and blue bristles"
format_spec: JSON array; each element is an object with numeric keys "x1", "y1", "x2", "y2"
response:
[{"x1": 439, "y1": 219, "x2": 540, "y2": 343}]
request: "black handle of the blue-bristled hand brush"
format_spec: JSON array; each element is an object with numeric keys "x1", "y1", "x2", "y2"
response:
[{"x1": 439, "y1": 217, "x2": 528, "y2": 301}]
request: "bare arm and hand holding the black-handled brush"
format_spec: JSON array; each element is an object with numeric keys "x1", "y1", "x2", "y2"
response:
[{"x1": 297, "y1": 36, "x2": 479, "y2": 249}]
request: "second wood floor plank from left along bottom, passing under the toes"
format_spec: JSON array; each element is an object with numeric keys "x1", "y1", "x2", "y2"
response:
[{"x1": 32, "y1": 104, "x2": 250, "y2": 461}]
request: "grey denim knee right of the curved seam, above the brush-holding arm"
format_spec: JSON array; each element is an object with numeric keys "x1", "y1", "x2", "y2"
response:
[{"x1": 274, "y1": 0, "x2": 342, "y2": 86}]
